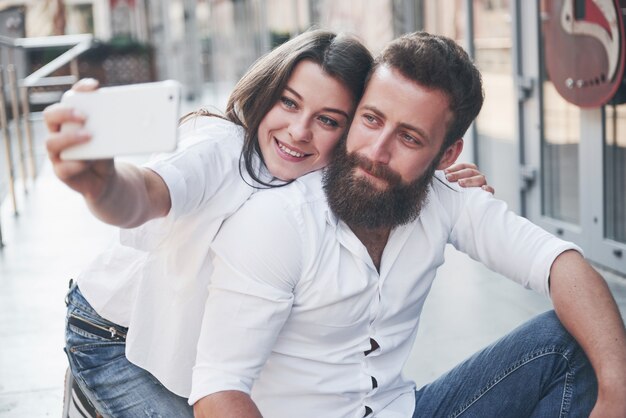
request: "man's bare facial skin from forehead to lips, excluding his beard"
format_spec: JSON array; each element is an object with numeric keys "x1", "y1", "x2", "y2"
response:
[{"x1": 346, "y1": 66, "x2": 452, "y2": 190}]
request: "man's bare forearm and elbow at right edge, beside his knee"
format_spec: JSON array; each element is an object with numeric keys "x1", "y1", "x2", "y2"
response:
[{"x1": 550, "y1": 251, "x2": 626, "y2": 418}]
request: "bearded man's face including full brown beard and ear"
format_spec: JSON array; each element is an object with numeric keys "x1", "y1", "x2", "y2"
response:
[{"x1": 324, "y1": 67, "x2": 462, "y2": 229}]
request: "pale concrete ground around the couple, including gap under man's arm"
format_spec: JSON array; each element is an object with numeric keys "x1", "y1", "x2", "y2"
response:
[{"x1": 0, "y1": 115, "x2": 626, "y2": 418}]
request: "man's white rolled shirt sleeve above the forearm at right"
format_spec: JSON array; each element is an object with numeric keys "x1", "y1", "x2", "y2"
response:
[{"x1": 450, "y1": 189, "x2": 582, "y2": 296}]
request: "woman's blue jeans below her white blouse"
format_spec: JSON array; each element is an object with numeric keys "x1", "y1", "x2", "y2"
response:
[{"x1": 65, "y1": 285, "x2": 193, "y2": 418}]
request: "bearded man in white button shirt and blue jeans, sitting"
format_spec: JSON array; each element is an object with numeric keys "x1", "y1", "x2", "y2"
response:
[{"x1": 190, "y1": 33, "x2": 626, "y2": 418}]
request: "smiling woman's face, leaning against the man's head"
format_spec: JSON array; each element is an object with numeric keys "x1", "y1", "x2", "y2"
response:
[{"x1": 258, "y1": 60, "x2": 355, "y2": 181}]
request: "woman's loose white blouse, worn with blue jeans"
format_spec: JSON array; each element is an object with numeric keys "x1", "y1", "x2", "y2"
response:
[{"x1": 78, "y1": 117, "x2": 255, "y2": 397}]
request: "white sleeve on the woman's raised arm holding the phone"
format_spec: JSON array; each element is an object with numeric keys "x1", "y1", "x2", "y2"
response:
[{"x1": 120, "y1": 116, "x2": 243, "y2": 251}]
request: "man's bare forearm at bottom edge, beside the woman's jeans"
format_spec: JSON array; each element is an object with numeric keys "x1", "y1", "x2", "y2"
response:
[{"x1": 193, "y1": 390, "x2": 262, "y2": 418}]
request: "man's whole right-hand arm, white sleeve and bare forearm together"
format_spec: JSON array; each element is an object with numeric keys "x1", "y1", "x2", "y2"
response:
[{"x1": 445, "y1": 190, "x2": 626, "y2": 418}]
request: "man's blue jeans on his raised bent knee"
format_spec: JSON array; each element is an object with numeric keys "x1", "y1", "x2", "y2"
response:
[{"x1": 413, "y1": 311, "x2": 597, "y2": 418}]
